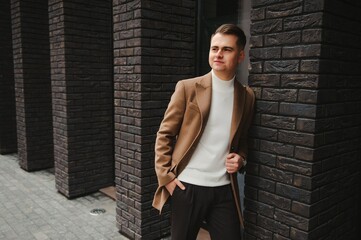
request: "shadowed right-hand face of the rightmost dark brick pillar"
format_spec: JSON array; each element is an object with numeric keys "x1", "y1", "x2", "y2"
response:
[{"x1": 314, "y1": 0, "x2": 361, "y2": 239}]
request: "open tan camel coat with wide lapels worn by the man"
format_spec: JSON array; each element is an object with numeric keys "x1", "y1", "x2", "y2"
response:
[{"x1": 153, "y1": 73, "x2": 255, "y2": 227}]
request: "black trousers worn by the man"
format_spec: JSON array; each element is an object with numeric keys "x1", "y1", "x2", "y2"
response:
[{"x1": 171, "y1": 183, "x2": 241, "y2": 240}]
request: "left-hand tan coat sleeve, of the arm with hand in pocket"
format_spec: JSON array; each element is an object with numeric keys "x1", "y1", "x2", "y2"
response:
[{"x1": 155, "y1": 81, "x2": 186, "y2": 187}]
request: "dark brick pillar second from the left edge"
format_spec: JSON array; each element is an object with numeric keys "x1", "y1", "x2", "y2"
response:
[{"x1": 11, "y1": 0, "x2": 54, "y2": 171}]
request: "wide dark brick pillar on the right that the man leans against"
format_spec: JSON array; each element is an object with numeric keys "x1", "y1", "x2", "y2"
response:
[{"x1": 245, "y1": 0, "x2": 361, "y2": 240}]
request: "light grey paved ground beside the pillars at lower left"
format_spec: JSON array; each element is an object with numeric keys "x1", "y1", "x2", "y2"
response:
[{"x1": 0, "y1": 155, "x2": 127, "y2": 240}]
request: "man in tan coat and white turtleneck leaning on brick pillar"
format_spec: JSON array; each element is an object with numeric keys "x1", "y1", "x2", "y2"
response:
[{"x1": 153, "y1": 24, "x2": 254, "y2": 240}]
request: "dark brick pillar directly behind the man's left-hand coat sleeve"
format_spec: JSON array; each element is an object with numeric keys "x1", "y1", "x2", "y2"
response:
[{"x1": 113, "y1": 1, "x2": 195, "y2": 239}]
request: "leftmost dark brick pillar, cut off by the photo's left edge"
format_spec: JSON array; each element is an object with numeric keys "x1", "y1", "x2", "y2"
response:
[{"x1": 0, "y1": 1, "x2": 17, "y2": 154}]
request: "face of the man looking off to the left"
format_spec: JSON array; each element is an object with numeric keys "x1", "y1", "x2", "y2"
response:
[{"x1": 208, "y1": 33, "x2": 244, "y2": 80}]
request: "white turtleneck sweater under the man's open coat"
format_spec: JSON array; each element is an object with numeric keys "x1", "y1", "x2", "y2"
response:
[{"x1": 178, "y1": 71, "x2": 235, "y2": 187}]
